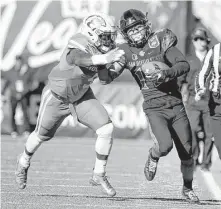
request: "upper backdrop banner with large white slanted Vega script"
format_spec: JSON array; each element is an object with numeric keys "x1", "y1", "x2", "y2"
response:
[{"x1": 0, "y1": 0, "x2": 186, "y2": 81}]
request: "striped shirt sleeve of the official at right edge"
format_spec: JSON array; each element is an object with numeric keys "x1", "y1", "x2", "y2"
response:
[{"x1": 195, "y1": 49, "x2": 213, "y2": 92}]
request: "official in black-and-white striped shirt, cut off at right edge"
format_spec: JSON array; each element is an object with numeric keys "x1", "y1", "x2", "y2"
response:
[{"x1": 195, "y1": 43, "x2": 221, "y2": 159}]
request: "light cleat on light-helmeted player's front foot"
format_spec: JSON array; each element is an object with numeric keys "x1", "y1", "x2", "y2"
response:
[{"x1": 89, "y1": 173, "x2": 116, "y2": 197}]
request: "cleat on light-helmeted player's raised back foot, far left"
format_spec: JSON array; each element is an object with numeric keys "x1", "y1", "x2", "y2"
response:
[{"x1": 15, "y1": 155, "x2": 30, "y2": 189}]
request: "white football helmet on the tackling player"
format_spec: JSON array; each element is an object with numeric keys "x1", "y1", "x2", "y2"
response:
[{"x1": 80, "y1": 14, "x2": 117, "y2": 53}]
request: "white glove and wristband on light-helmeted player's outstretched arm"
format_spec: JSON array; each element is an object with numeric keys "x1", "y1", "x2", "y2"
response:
[{"x1": 91, "y1": 48, "x2": 125, "y2": 65}]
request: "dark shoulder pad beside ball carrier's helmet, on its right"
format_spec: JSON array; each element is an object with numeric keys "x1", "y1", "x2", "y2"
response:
[{"x1": 155, "y1": 28, "x2": 177, "y2": 51}]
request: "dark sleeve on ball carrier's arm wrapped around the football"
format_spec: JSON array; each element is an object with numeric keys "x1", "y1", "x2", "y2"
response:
[{"x1": 163, "y1": 46, "x2": 190, "y2": 80}]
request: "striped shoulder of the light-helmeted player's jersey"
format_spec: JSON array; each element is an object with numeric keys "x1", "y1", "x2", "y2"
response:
[{"x1": 67, "y1": 33, "x2": 89, "y2": 52}]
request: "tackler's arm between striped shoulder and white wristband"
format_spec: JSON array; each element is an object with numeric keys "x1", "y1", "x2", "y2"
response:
[{"x1": 66, "y1": 48, "x2": 93, "y2": 67}]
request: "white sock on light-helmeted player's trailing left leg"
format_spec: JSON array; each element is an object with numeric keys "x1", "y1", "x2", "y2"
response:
[{"x1": 19, "y1": 131, "x2": 43, "y2": 167}]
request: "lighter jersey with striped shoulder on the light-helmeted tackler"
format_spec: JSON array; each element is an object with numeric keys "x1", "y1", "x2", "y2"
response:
[{"x1": 48, "y1": 33, "x2": 100, "y2": 103}]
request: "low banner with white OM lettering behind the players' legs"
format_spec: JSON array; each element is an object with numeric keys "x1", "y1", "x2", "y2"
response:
[{"x1": 1, "y1": 83, "x2": 150, "y2": 139}]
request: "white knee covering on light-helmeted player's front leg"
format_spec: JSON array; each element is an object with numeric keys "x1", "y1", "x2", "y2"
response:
[{"x1": 95, "y1": 123, "x2": 114, "y2": 155}]
